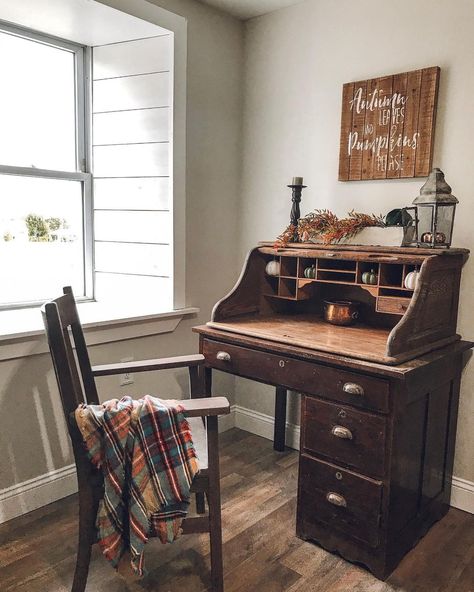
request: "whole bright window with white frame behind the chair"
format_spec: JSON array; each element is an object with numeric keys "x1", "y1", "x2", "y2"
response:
[{"x1": 0, "y1": 24, "x2": 92, "y2": 308}]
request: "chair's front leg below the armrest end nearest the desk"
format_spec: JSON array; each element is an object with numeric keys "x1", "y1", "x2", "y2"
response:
[{"x1": 207, "y1": 417, "x2": 224, "y2": 592}]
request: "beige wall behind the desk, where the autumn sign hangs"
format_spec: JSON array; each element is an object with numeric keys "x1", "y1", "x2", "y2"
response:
[{"x1": 237, "y1": 0, "x2": 474, "y2": 481}]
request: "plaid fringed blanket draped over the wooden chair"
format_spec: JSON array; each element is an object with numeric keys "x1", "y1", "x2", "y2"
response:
[{"x1": 75, "y1": 395, "x2": 199, "y2": 575}]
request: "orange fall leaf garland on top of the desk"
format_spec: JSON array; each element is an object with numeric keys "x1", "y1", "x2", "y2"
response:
[{"x1": 275, "y1": 210, "x2": 385, "y2": 248}]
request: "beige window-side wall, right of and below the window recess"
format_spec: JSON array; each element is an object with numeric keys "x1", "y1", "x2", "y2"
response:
[{"x1": 0, "y1": 0, "x2": 243, "y2": 490}]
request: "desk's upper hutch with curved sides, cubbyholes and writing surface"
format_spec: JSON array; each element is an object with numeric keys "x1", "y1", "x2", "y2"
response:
[{"x1": 209, "y1": 243, "x2": 468, "y2": 364}]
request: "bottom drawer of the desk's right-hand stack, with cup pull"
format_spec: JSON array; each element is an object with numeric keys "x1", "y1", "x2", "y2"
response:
[{"x1": 298, "y1": 454, "x2": 383, "y2": 547}]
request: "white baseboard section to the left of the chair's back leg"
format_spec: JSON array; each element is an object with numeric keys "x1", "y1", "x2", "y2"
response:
[{"x1": 0, "y1": 465, "x2": 77, "y2": 524}]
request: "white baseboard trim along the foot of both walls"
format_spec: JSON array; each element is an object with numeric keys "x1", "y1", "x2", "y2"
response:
[{"x1": 0, "y1": 405, "x2": 474, "y2": 524}]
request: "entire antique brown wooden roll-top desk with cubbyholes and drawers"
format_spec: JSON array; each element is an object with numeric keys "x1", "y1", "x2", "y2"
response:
[{"x1": 195, "y1": 243, "x2": 473, "y2": 579}]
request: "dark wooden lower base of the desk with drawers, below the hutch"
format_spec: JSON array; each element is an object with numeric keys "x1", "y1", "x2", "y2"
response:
[{"x1": 194, "y1": 326, "x2": 473, "y2": 579}]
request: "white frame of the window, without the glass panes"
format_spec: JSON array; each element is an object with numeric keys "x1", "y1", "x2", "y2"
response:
[{"x1": 0, "y1": 21, "x2": 94, "y2": 311}]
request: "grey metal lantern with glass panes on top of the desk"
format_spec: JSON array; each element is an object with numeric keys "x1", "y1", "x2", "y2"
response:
[{"x1": 406, "y1": 169, "x2": 458, "y2": 248}]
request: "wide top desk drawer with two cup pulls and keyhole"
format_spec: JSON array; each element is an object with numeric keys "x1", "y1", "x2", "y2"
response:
[{"x1": 202, "y1": 339, "x2": 390, "y2": 413}]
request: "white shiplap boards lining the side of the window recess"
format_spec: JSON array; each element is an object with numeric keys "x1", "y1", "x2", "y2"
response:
[{"x1": 92, "y1": 34, "x2": 173, "y2": 309}]
